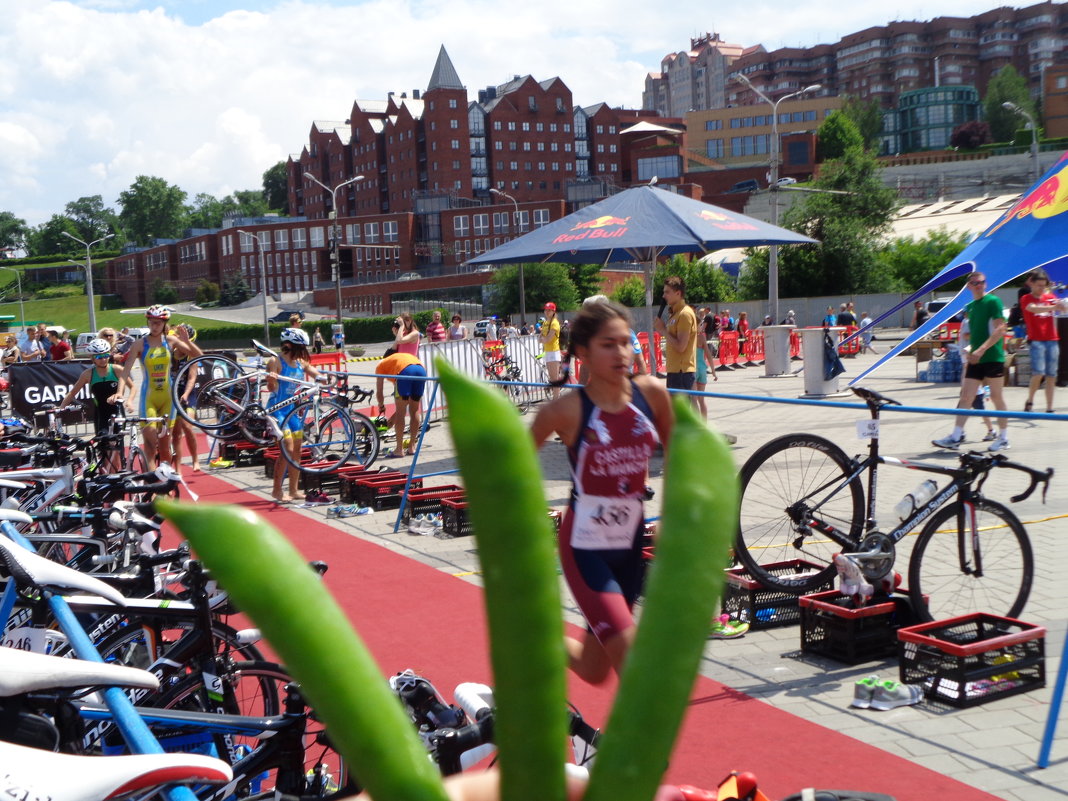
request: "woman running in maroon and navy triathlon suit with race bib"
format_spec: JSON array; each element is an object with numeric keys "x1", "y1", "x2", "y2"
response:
[{"x1": 533, "y1": 301, "x2": 674, "y2": 684}]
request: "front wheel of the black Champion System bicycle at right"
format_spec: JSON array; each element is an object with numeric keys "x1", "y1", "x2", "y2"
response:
[{"x1": 909, "y1": 498, "x2": 1035, "y2": 621}]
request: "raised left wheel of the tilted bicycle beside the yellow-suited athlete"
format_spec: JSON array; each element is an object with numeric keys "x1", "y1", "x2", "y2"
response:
[{"x1": 171, "y1": 356, "x2": 249, "y2": 431}]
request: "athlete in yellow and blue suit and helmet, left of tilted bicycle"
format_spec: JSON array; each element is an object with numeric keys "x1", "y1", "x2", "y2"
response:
[{"x1": 122, "y1": 305, "x2": 203, "y2": 467}]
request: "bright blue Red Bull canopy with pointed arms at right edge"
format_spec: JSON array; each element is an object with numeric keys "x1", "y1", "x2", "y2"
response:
[{"x1": 850, "y1": 152, "x2": 1068, "y2": 383}]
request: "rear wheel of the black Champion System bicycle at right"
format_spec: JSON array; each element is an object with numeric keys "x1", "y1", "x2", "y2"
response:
[{"x1": 735, "y1": 434, "x2": 864, "y2": 593}]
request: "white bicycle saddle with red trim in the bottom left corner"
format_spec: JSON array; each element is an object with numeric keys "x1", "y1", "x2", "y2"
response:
[{"x1": 0, "y1": 742, "x2": 234, "y2": 801}]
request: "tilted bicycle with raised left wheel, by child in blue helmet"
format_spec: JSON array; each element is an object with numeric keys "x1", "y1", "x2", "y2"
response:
[{"x1": 174, "y1": 340, "x2": 379, "y2": 473}]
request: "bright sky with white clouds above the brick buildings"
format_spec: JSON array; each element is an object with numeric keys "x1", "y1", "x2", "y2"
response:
[{"x1": 6, "y1": 0, "x2": 999, "y2": 224}]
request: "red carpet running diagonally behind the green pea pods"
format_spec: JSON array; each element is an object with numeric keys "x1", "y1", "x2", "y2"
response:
[{"x1": 175, "y1": 473, "x2": 995, "y2": 801}]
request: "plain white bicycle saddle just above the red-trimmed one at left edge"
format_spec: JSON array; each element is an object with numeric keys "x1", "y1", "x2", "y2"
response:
[{"x1": 0, "y1": 647, "x2": 159, "y2": 697}]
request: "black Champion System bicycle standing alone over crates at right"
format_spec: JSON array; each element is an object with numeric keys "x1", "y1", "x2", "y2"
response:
[{"x1": 735, "y1": 387, "x2": 1053, "y2": 621}]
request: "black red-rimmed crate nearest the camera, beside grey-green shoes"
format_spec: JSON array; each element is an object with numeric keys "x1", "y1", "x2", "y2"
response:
[{"x1": 897, "y1": 612, "x2": 1046, "y2": 708}]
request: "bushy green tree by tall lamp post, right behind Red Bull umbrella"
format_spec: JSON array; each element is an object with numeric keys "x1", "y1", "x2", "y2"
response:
[{"x1": 739, "y1": 146, "x2": 898, "y2": 300}]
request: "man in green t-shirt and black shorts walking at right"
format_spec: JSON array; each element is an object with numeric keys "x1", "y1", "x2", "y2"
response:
[{"x1": 932, "y1": 272, "x2": 1009, "y2": 451}]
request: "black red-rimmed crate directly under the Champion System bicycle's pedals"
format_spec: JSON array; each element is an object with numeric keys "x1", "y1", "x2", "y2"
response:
[{"x1": 799, "y1": 590, "x2": 915, "y2": 664}]
